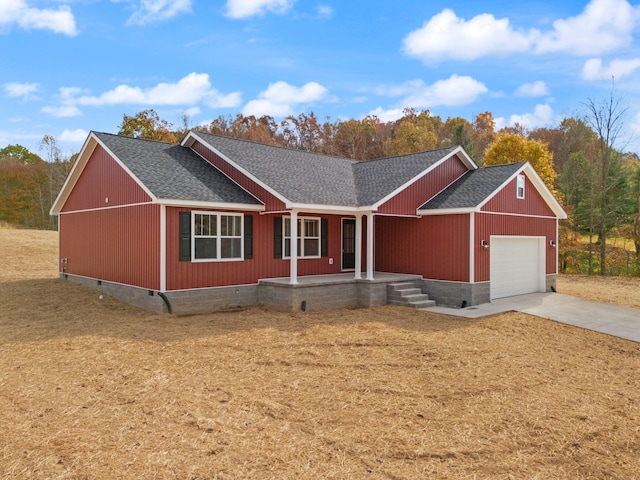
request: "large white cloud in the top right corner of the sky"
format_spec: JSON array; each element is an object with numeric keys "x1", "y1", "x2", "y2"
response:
[{"x1": 536, "y1": 0, "x2": 639, "y2": 55}]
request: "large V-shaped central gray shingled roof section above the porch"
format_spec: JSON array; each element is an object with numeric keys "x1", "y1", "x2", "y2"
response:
[{"x1": 196, "y1": 132, "x2": 457, "y2": 206}]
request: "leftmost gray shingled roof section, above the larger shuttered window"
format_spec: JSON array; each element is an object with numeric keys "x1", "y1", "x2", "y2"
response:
[{"x1": 94, "y1": 132, "x2": 262, "y2": 205}]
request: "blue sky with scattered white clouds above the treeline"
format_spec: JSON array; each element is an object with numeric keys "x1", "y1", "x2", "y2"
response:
[{"x1": 0, "y1": 0, "x2": 640, "y2": 155}]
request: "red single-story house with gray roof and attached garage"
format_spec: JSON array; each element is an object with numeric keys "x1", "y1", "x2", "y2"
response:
[{"x1": 51, "y1": 131, "x2": 566, "y2": 313}]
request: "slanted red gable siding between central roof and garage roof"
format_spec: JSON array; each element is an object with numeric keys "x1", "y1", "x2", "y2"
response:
[{"x1": 377, "y1": 155, "x2": 469, "y2": 215}]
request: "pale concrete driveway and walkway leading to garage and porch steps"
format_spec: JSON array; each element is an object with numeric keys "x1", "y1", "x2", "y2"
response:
[{"x1": 427, "y1": 293, "x2": 640, "y2": 342}]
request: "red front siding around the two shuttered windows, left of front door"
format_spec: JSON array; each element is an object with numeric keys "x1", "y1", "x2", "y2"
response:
[{"x1": 167, "y1": 207, "x2": 350, "y2": 290}]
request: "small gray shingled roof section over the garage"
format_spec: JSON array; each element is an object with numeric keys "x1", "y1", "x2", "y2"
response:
[{"x1": 418, "y1": 162, "x2": 524, "y2": 210}]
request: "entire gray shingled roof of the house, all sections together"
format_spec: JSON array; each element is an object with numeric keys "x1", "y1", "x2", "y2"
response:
[{"x1": 94, "y1": 132, "x2": 523, "y2": 210}]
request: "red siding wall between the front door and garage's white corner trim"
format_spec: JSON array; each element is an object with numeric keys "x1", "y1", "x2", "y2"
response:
[{"x1": 375, "y1": 214, "x2": 469, "y2": 282}]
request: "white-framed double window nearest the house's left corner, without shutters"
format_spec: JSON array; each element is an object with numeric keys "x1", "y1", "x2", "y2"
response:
[{"x1": 191, "y1": 212, "x2": 243, "y2": 261}]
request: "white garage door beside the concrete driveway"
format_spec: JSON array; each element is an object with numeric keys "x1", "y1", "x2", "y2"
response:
[{"x1": 489, "y1": 237, "x2": 545, "y2": 300}]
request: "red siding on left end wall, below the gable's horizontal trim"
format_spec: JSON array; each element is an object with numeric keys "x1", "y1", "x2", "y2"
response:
[{"x1": 59, "y1": 204, "x2": 160, "y2": 290}]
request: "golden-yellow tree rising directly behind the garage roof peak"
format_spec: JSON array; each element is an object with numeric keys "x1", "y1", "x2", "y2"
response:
[{"x1": 484, "y1": 133, "x2": 558, "y2": 195}]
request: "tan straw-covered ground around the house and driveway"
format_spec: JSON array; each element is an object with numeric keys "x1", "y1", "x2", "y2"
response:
[{"x1": 0, "y1": 229, "x2": 640, "y2": 480}]
